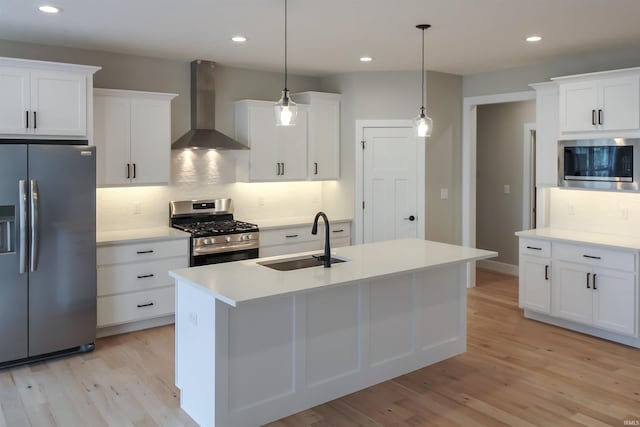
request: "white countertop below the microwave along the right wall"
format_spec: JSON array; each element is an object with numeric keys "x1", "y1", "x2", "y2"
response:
[{"x1": 516, "y1": 227, "x2": 640, "y2": 250}]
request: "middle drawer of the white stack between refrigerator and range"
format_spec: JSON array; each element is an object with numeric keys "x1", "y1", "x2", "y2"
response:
[{"x1": 98, "y1": 257, "x2": 189, "y2": 296}]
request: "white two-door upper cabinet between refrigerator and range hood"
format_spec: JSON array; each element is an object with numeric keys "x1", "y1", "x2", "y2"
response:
[{"x1": 94, "y1": 89, "x2": 177, "y2": 187}]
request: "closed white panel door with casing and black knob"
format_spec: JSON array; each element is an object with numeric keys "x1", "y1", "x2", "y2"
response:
[{"x1": 354, "y1": 120, "x2": 428, "y2": 243}]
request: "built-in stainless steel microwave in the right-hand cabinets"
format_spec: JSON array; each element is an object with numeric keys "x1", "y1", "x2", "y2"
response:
[{"x1": 558, "y1": 138, "x2": 640, "y2": 191}]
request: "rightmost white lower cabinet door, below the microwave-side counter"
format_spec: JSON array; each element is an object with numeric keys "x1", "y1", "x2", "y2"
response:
[{"x1": 592, "y1": 268, "x2": 637, "y2": 335}]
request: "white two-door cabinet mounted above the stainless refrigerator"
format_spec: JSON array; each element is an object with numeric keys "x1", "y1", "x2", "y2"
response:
[{"x1": 0, "y1": 58, "x2": 100, "y2": 140}]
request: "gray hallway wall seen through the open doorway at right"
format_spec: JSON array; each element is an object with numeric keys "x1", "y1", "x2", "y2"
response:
[{"x1": 476, "y1": 101, "x2": 536, "y2": 265}]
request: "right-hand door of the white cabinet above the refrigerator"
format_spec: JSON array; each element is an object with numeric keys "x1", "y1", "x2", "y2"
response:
[{"x1": 30, "y1": 71, "x2": 87, "y2": 136}]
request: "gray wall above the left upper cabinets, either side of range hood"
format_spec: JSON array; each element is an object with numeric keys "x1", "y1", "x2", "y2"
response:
[{"x1": 0, "y1": 40, "x2": 320, "y2": 141}]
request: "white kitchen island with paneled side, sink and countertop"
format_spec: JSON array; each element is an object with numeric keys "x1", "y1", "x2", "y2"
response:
[{"x1": 169, "y1": 239, "x2": 497, "y2": 427}]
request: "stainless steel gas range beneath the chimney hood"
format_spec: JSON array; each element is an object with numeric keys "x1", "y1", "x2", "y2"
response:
[{"x1": 169, "y1": 199, "x2": 260, "y2": 267}]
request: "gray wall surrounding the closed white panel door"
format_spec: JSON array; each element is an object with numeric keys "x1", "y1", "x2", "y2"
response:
[{"x1": 322, "y1": 72, "x2": 462, "y2": 243}]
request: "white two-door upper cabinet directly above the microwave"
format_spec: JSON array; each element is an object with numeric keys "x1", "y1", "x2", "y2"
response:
[{"x1": 553, "y1": 69, "x2": 640, "y2": 137}]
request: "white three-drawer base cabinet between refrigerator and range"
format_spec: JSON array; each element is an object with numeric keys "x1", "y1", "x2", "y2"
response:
[{"x1": 97, "y1": 238, "x2": 189, "y2": 335}]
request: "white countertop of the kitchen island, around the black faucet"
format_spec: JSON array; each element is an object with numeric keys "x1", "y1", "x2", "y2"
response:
[{"x1": 169, "y1": 239, "x2": 498, "y2": 307}]
